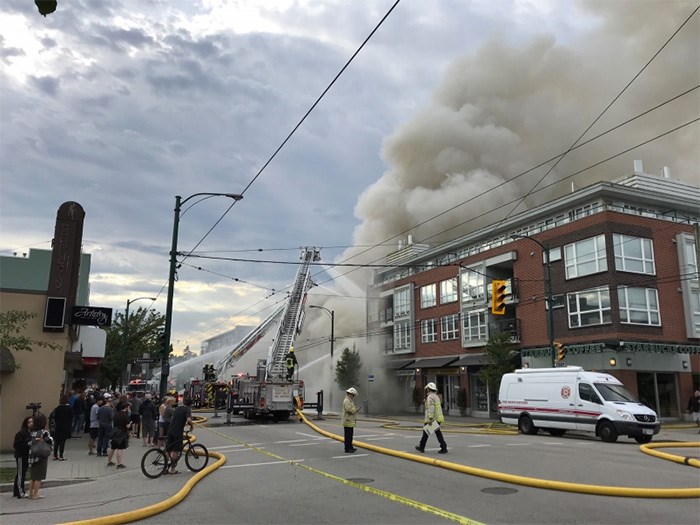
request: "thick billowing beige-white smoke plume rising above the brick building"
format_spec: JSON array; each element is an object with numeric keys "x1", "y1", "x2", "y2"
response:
[{"x1": 345, "y1": 2, "x2": 700, "y2": 260}]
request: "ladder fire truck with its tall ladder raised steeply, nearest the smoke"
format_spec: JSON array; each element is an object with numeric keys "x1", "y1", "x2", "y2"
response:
[{"x1": 232, "y1": 247, "x2": 321, "y2": 421}]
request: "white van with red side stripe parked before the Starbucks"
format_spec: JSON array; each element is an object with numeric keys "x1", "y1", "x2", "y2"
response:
[{"x1": 498, "y1": 366, "x2": 661, "y2": 443}]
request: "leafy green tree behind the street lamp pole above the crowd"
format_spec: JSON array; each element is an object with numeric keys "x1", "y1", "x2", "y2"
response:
[{"x1": 99, "y1": 307, "x2": 165, "y2": 386}]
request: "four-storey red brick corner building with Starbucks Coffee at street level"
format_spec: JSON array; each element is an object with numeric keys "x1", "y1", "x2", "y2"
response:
[{"x1": 367, "y1": 166, "x2": 700, "y2": 420}]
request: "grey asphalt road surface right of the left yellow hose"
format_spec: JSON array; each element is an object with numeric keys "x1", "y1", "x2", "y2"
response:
[{"x1": 138, "y1": 419, "x2": 700, "y2": 525}]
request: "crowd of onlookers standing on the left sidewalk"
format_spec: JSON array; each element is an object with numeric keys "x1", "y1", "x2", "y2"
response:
[{"x1": 13, "y1": 390, "x2": 177, "y2": 499}]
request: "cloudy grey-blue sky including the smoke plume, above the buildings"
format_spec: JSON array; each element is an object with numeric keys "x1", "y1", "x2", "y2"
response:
[{"x1": 0, "y1": 0, "x2": 700, "y2": 364}]
